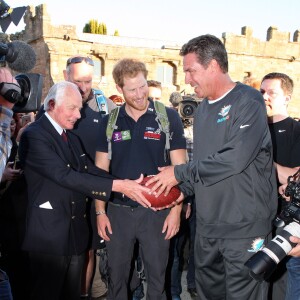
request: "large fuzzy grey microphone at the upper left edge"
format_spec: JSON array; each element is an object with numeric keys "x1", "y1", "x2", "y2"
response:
[{"x1": 0, "y1": 41, "x2": 36, "y2": 73}]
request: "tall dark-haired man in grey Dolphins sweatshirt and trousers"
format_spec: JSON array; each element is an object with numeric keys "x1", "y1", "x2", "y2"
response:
[{"x1": 152, "y1": 35, "x2": 277, "y2": 300}]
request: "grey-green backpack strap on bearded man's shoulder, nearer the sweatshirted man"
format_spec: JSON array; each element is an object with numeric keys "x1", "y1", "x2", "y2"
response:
[{"x1": 153, "y1": 101, "x2": 170, "y2": 161}]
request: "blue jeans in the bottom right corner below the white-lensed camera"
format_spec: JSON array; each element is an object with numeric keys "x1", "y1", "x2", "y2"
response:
[{"x1": 285, "y1": 257, "x2": 300, "y2": 300}]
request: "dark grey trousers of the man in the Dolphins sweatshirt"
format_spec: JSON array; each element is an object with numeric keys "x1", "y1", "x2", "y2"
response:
[{"x1": 195, "y1": 234, "x2": 270, "y2": 300}]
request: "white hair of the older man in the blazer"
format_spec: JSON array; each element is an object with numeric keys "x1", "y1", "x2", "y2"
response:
[{"x1": 44, "y1": 81, "x2": 79, "y2": 111}]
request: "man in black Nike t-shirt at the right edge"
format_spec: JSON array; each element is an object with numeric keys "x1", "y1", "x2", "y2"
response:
[{"x1": 260, "y1": 73, "x2": 300, "y2": 300}]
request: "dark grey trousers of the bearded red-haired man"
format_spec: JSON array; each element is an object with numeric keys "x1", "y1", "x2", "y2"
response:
[{"x1": 106, "y1": 204, "x2": 169, "y2": 300}]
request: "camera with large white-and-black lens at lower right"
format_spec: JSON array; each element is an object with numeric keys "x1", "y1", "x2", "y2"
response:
[{"x1": 245, "y1": 169, "x2": 300, "y2": 281}]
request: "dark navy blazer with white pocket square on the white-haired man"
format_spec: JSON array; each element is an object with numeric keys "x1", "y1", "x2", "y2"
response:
[{"x1": 19, "y1": 115, "x2": 113, "y2": 255}]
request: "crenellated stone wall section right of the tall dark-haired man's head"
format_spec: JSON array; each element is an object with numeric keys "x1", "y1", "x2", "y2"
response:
[{"x1": 222, "y1": 27, "x2": 300, "y2": 116}]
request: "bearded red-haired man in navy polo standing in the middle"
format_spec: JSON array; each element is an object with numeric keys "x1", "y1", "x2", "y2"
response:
[{"x1": 96, "y1": 59, "x2": 186, "y2": 300}]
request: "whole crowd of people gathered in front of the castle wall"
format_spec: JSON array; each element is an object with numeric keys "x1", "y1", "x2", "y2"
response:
[{"x1": 0, "y1": 35, "x2": 300, "y2": 300}]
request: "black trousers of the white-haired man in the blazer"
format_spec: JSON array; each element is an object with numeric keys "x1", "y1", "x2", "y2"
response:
[{"x1": 29, "y1": 252, "x2": 85, "y2": 300}]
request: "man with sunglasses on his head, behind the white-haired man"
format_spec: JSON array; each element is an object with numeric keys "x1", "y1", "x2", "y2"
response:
[{"x1": 63, "y1": 56, "x2": 116, "y2": 298}]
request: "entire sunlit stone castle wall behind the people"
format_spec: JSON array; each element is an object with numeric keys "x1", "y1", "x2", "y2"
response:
[{"x1": 13, "y1": 4, "x2": 300, "y2": 117}]
